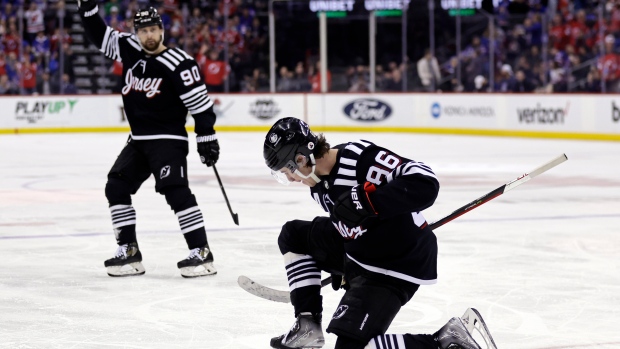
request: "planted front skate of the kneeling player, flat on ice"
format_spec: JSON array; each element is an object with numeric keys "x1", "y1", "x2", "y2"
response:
[{"x1": 270, "y1": 313, "x2": 325, "y2": 349}]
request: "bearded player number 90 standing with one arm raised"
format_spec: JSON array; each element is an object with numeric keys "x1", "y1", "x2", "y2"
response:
[{"x1": 78, "y1": 0, "x2": 220, "y2": 277}]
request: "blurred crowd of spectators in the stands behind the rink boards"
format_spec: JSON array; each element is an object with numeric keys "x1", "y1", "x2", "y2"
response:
[{"x1": 0, "y1": 0, "x2": 620, "y2": 94}]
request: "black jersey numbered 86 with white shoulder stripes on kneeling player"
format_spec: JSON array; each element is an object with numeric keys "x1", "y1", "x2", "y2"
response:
[{"x1": 310, "y1": 141, "x2": 439, "y2": 285}]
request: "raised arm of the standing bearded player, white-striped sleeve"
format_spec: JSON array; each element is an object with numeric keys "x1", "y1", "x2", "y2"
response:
[{"x1": 78, "y1": 0, "x2": 142, "y2": 62}]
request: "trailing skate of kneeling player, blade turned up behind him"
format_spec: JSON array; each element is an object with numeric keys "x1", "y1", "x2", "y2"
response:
[{"x1": 434, "y1": 308, "x2": 497, "y2": 349}]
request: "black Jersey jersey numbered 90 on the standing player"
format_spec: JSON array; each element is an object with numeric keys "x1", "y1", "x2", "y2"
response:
[{"x1": 80, "y1": 11, "x2": 215, "y2": 140}]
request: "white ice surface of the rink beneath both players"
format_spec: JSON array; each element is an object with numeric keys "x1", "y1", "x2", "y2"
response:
[{"x1": 0, "y1": 132, "x2": 620, "y2": 349}]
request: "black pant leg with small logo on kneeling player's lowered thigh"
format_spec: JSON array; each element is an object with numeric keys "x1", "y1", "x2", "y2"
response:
[{"x1": 327, "y1": 277, "x2": 402, "y2": 342}]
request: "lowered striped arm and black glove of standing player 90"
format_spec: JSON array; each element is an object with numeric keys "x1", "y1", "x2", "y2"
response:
[{"x1": 168, "y1": 55, "x2": 220, "y2": 166}]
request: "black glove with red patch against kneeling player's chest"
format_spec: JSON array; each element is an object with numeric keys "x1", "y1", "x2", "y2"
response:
[{"x1": 332, "y1": 182, "x2": 377, "y2": 228}]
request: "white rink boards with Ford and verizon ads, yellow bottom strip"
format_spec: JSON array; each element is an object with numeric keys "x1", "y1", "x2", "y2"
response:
[{"x1": 0, "y1": 93, "x2": 620, "y2": 141}]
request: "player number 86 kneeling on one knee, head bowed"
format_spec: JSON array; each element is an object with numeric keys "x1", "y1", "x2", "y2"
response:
[{"x1": 263, "y1": 118, "x2": 495, "y2": 349}]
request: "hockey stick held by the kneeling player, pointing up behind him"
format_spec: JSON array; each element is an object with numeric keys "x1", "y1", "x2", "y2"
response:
[{"x1": 237, "y1": 154, "x2": 568, "y2": 303}]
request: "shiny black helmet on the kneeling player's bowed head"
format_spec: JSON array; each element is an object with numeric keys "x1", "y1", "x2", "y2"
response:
[{"x1": 263, "y1": 118, "x2": 318, "y2": 172}]
